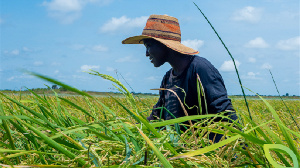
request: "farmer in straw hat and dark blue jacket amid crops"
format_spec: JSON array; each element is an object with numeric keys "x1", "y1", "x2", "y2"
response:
[{"x1": 122, "y1": 15, "x2": 237, "y2": 142}]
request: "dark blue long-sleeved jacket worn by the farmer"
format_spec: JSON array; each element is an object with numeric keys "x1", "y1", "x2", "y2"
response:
[{"x1": 147, "y1": 56, "x2": 237, "y2": 120}]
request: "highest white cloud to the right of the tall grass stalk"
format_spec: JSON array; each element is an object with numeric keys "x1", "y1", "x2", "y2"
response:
[{"x1": 232, "y1": 6, "x2": 262, "y2": 23}]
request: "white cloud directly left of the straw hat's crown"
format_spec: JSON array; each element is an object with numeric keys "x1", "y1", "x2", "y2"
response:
[{"x1": 100, "y1": 16, "x2": 148, "y2": 33}]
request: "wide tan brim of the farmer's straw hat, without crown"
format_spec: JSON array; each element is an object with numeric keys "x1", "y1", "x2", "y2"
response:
[{"x1": 122, "y1": 35, "x2": 199, "y2": 55}]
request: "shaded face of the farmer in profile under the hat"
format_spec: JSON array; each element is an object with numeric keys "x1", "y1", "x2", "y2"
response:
[{"x1": 143, "y1": 39, "x2": 167, "y2": 67}]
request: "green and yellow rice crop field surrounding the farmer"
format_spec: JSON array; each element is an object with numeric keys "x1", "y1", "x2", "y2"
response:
[{"x1": 0, "y1": 71, "x2": 300, "y2": 167}]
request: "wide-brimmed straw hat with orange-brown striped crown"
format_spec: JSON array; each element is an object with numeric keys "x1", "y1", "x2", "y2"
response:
[{"x1": 122, "y1": 15, "x2": 199, "y2": 55}]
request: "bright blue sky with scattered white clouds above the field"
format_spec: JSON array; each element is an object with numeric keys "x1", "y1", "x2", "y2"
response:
[{"x1": 0, "y1": 0, "x2": 300, "y2": 95}]
